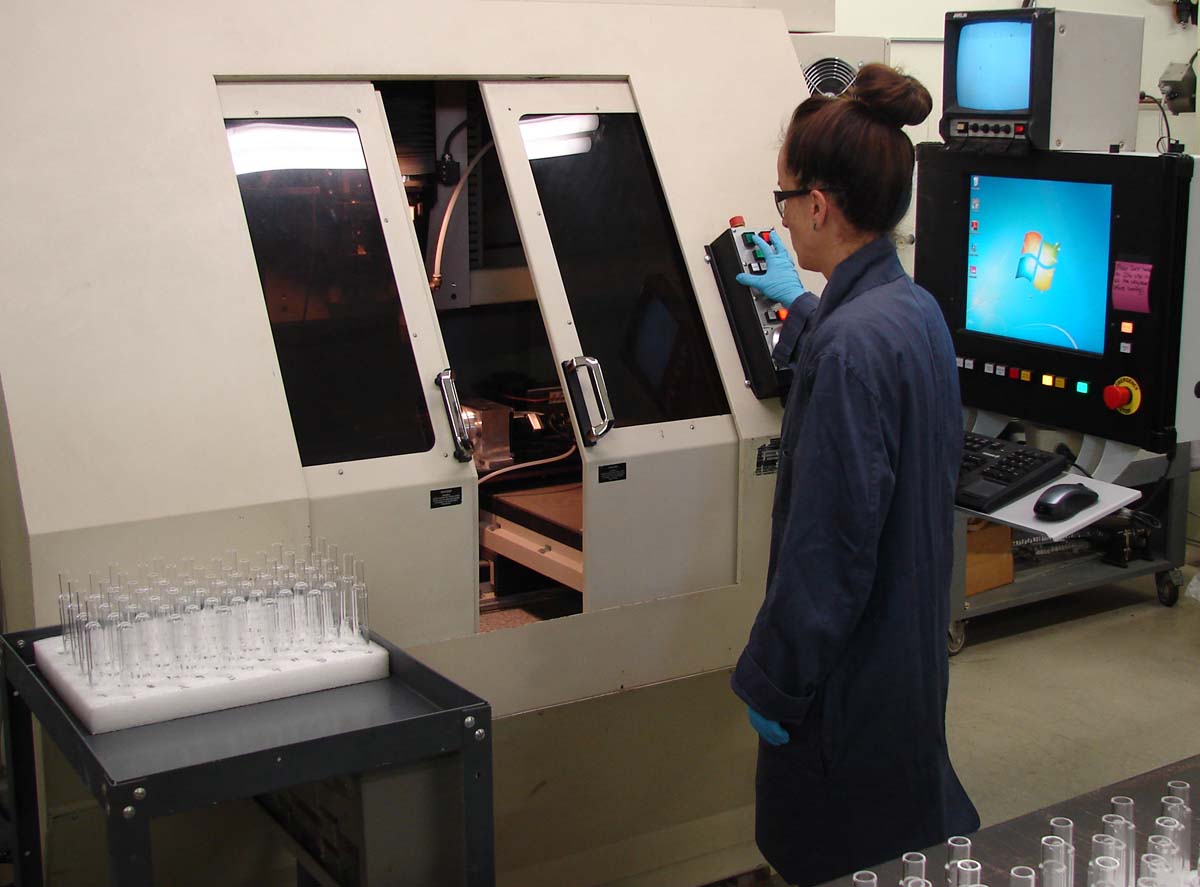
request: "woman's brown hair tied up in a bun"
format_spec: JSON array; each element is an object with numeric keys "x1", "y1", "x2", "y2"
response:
[{"x1": 784, "y1": 64, "x2": 934, "y2": 233}]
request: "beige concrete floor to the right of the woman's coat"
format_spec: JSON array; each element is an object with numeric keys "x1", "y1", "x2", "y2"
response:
[{"x1": 947, "y1": 549, "x2": 1200, "y2": 826}]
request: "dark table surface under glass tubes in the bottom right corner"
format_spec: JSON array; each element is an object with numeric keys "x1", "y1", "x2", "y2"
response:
[{"x1": 829, "y1": 756, "x2": 1200, "y2": 887}]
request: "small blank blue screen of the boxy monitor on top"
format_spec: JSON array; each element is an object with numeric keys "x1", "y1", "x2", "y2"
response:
[{"x1": 955, "y1": 20, "x2": 1033, "y2": 112}]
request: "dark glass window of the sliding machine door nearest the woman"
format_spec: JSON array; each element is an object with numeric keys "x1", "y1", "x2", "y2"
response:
[{"x1": 521, "y1": 113, "x2": 730, "y2": 426}]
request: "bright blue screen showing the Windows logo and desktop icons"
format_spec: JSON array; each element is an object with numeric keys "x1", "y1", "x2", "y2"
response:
[{"x1": 966, "y1": 174, "x2": 1112, "y2": 354}]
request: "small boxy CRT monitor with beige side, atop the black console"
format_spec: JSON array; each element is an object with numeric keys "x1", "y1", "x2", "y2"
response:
[{"x1": 941, "y1": 7, "x2": 1142, "y2": 151}]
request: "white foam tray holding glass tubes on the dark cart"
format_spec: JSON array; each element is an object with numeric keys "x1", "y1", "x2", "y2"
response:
[{"x1": 34, "y1": 637, "x2": 388, "y2": 733}]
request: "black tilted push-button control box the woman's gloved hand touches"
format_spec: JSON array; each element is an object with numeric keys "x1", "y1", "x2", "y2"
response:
[{"x1": 704, "y1": 216, "x2": 792, "y2": 400}]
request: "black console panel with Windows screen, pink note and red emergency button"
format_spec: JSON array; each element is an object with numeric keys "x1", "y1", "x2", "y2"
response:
[{"x1": 914, "y1": 144, "x2": 1193, "y2": 453}]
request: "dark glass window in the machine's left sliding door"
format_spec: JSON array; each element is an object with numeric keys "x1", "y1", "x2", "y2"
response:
[{"x1": 226, "y1": 118, "x2": 433, "y2": 466}]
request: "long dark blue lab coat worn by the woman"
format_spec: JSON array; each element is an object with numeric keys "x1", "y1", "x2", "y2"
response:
[{"x1": 733, "y1": 238, "x2": 979, "y2": 885}]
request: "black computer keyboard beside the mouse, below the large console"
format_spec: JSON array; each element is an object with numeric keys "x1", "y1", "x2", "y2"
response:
[{"x1": 954, "y1": 431, "x2": 1070, "y2": 514}]
